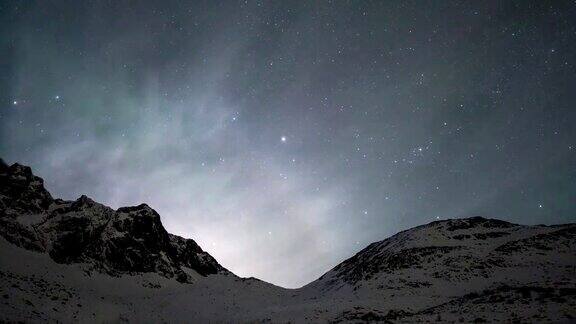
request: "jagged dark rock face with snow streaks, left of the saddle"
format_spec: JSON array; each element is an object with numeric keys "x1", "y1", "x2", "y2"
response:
[{"x1": 0, "y1": 161, "x2": 228, "y2": 282}]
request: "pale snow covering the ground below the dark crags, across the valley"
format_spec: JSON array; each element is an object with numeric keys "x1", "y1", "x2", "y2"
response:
[{"x1": 0, "y1": 218, "x2": 576, "y2": 322}]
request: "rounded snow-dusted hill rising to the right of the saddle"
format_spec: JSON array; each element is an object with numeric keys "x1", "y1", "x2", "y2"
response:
[{"x1": 302, "y1": 217, "x2": 576, "y2": 322}]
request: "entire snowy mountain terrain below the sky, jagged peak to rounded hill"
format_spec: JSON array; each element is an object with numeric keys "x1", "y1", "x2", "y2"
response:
[{"x1": 0, "y1": 160, "x2": 576, "y2": 323}]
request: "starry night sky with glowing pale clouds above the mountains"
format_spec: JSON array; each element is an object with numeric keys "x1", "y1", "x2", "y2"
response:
[{"x1": 0, "y1": 0, "x2": 576, "y2": 287}]
